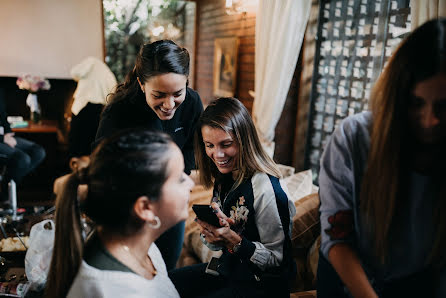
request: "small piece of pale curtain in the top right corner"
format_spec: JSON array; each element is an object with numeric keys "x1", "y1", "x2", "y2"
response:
[{"x1": 410, "y1": 0, "x2": 446, "y2": 30}]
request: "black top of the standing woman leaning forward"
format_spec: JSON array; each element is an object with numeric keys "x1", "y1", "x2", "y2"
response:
[{"x1": 94, "y1": 88, "x2": 203, "y2": 174}]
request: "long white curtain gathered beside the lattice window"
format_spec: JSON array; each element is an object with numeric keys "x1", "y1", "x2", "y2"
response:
[{"x1": 253, "y1": 0, "x2": 311, "y2": 156}]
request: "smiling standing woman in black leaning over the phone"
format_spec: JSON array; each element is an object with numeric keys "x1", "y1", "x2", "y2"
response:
[{"x1": 96, "y1": 40, "x2": 203, "y2": 269}]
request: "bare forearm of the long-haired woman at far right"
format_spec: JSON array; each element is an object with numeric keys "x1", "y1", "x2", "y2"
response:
[{"x1": 328, "y1": 243, "x2": 378, "y2": 298}]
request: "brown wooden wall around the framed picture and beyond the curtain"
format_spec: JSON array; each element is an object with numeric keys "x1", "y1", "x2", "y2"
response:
[{"x1": 195, "y1": 0, "x2": 301, "y2": 165}]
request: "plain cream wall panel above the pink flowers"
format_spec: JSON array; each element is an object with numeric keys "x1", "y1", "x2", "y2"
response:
[{"x1": 0, "y1": 0, "x2": 104, "y2": 78}]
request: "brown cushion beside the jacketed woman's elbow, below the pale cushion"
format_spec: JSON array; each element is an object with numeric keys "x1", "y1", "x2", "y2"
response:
[{"x1": 291, "y1": 193, "x2": 320, "y2": 255}]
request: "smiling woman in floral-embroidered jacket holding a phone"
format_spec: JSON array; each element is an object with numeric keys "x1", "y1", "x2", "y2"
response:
[{"x1": 169, "y1": 98, "x2": 295, "y2": 297}]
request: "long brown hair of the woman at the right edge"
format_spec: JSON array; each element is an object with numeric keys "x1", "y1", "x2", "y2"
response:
[{"x1": 360, "y1": 18, "x2": 446, "y2": 263}]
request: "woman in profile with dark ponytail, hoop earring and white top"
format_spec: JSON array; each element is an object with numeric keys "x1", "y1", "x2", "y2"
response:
[{"x1": 45, "y1": 130, "x2": 194, "y2": 297}]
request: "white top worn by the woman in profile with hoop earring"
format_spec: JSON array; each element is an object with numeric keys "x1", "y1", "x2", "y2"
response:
[{"x1": 67, "y1": 243, "x2": 180, "y2": 298}]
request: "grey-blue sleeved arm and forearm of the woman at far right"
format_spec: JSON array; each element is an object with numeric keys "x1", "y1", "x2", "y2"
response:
[{"x1": 319, "y1": 113, "x2": 377, "y2": 297}]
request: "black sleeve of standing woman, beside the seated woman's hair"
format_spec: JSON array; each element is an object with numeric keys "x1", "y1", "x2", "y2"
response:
[{"x1": 182, "y1": 90, "x2": 203, "y2": 175}]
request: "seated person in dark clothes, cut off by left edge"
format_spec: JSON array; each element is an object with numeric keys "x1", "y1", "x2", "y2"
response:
[{"x1": 0, "y1": 88, "x2": 45, "y2": 199}]
